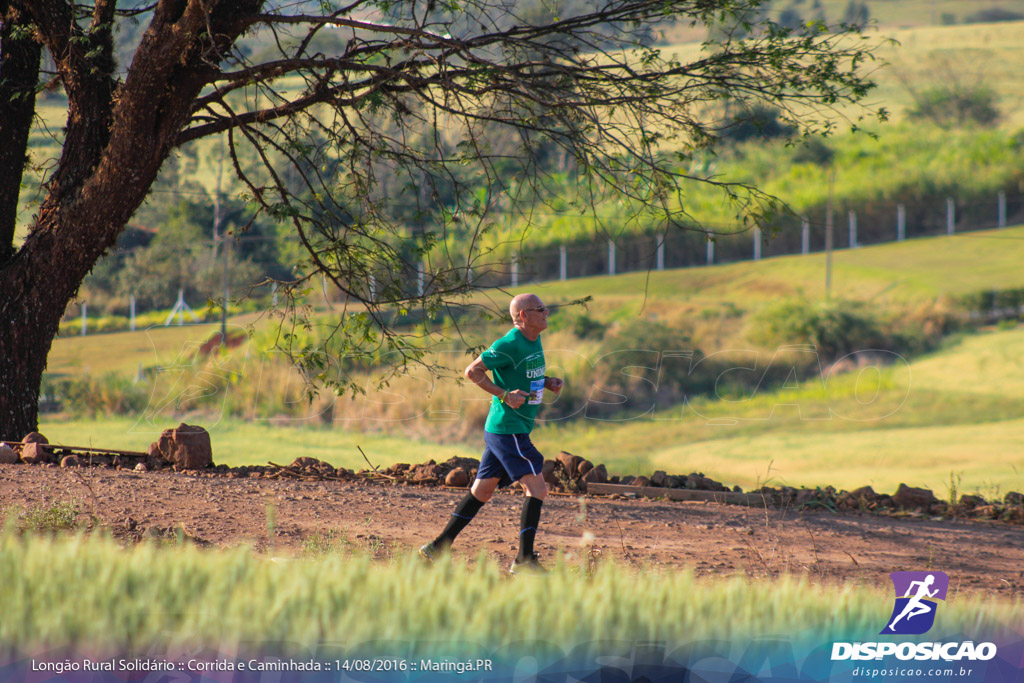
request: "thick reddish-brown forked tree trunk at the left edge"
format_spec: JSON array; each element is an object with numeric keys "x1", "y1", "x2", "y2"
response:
[{"x1": 0, "y1": 0, "x2": 262, "y2": 439}]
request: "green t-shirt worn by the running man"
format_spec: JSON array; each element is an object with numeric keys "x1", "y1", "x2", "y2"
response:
[{"x1": 480, "y1": 328, "x2": 545, "y2": 434}]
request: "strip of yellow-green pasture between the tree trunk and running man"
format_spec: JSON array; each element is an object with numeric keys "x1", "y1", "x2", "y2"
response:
[{"x1": 39, "y1": 416, "x2": 482, "y2": 470}]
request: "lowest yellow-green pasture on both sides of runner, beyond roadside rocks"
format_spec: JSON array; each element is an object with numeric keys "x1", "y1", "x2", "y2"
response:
[{"x1": 41, "y1": 328, "x2": 1024, "y2": 498}]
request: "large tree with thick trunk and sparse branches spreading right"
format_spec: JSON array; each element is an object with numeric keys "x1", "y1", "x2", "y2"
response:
[{"x1": 0, "y1": 0, "x2": 870, "y2": 438}]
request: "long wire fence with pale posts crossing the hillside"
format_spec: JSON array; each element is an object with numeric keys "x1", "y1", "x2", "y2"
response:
[{"x1": 65, "y1": 191, "x2": 1024, "y2": 335}]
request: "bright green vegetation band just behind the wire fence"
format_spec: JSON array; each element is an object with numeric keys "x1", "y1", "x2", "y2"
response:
[{"x1": 483, "y1": 122, "x2": 1024, "y2": 252}]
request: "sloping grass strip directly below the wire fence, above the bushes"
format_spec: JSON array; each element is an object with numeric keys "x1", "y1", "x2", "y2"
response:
[{"x1": 47, "y1": 226, "x2": 1024, "y2": 375}]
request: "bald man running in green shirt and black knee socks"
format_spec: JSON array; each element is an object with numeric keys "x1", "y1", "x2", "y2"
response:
[{"x1": 420, "y1": 294, "x2": 562, "y2": 573}]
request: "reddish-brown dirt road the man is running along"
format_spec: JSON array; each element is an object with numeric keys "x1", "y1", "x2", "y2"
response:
[{"x1": 0, "y1": 465, "x2": 1024, "y2": 597}]
